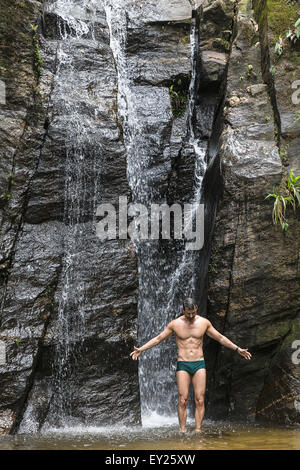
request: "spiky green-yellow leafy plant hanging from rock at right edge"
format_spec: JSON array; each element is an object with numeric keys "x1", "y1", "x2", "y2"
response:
[{"x1": 265, "y1": 171, "x2": 300, "y2": 231}]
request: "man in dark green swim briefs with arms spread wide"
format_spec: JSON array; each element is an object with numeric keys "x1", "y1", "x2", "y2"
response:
[{"x1": 130, "y1": 298, "x2": 251, "y2": 432}]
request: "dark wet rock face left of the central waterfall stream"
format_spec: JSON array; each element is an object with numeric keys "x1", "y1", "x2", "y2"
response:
[{"x1": 0, "y1": 1, "x2": 139, "y2": 432}]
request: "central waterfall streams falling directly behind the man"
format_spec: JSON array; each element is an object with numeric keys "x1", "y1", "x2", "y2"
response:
[{"x1": 105, "y1": 0, "x2": 207, "y2": 425}]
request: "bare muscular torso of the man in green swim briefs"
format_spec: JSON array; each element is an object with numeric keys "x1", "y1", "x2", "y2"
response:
[{"x1": 172, "y1": 315, "x2": 208, "y2": 361}]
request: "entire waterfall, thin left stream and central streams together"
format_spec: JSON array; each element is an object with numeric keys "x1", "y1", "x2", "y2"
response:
[{"x1": 21, "y1": 0, "x2": 216, "y2": 425}]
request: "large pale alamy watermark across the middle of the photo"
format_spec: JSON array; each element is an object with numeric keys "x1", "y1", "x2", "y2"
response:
[{"x1": 96, "y1": 196, "x2": 204, "y2": 250}]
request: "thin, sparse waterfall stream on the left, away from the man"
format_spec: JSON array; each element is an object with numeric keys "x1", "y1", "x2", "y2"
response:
[{"x1": 45, "y1": 0, "x2": 101, "y2": 424}]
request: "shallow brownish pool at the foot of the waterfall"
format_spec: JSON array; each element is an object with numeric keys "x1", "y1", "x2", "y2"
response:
[{"x1": 0, "y1": 421, "x2": 300, "y2": 452}]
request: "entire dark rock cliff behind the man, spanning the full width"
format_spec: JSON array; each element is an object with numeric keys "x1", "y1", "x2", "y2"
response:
[{"x1": 0, "y1": 0, "x2": 300, "y2": 433}]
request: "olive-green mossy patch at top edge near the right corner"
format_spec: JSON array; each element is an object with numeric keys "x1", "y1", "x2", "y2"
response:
[{"x1": 267, "y1": 0, "x2": 299, "y2": 37}]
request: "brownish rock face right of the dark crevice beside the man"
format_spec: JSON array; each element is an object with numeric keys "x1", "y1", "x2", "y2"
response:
[{"x1": 207, "y1": 2, "x2": 300, "y2": 424}]
